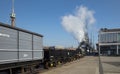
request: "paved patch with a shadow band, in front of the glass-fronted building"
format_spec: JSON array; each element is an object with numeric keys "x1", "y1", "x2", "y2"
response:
[{"x1": 100, "y1": 56, "x2": 120, "y2": 74}]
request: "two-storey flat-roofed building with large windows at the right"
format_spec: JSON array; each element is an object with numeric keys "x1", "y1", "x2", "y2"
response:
[{"x1": 98, "y1": 28, "x2": 120, "y2": 56}]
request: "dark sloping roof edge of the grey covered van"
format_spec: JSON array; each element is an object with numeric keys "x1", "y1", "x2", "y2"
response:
[{"x1": 0, "y1": 22, "x2": 43, "y2": 37}]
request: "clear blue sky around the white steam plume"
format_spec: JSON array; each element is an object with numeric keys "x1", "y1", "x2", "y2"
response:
[{"x1": 0, "y1": 0, "x2": 120, "y2": 47}]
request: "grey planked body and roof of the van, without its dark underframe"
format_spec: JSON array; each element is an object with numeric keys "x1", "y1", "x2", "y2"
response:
[{"x1": 0, "y1": 23, "x2": 44, "y2": 64}]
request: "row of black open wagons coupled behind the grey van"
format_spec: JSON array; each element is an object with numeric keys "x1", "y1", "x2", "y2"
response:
[{"x1": 44, "y1": 47, "x2": 76, "y2": 69}]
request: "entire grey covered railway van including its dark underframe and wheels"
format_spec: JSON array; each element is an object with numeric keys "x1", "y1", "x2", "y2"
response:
[{"x1": 0, "y1": 23, "x2": 44, "y2": 74}]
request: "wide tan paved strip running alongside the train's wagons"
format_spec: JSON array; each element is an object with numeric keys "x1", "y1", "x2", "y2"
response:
[{"x1": 40, "y1": 56, "x2": 99, "y2": 74}]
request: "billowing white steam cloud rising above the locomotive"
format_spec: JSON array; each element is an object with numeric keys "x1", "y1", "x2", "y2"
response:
[{"x1": 62, "y1": 6, "x2": 95, "y2": 42}]
